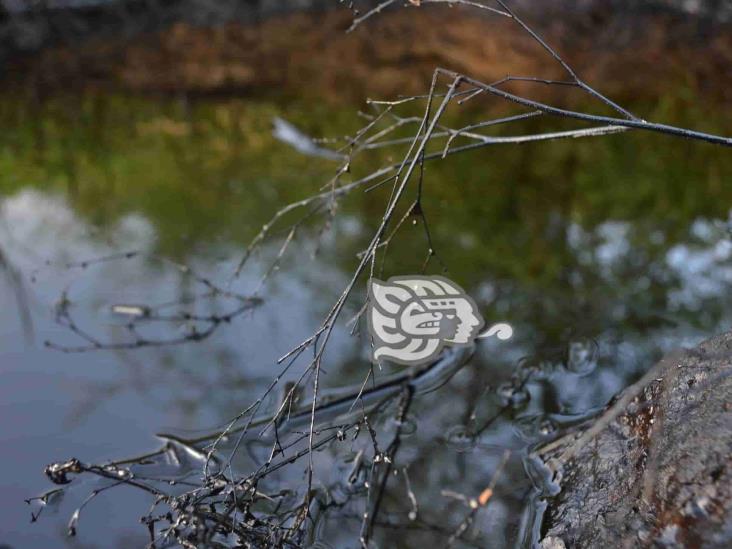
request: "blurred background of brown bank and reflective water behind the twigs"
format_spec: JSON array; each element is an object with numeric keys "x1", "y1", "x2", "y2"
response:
[{"x1": 0, "y1": 0, "x2": 732, "y2": 548}]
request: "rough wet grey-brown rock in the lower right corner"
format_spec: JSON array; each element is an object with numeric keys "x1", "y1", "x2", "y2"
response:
[{"x1": 541, "y1": 333, "x2": 732, "y2": 548}]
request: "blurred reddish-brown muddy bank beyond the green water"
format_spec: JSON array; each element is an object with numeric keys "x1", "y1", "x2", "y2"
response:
[{"x1": 5, "y1": 8, "x2": 732, "y2": 102}]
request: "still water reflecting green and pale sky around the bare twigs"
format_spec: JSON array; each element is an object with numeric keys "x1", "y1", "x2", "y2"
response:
[{"x1": 0, "y1": 93, "x2": 732, "y2": 548}]
